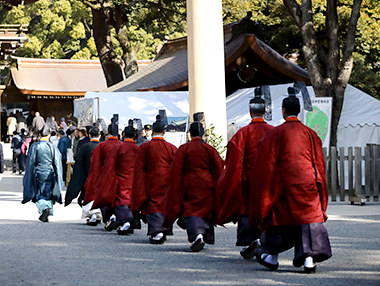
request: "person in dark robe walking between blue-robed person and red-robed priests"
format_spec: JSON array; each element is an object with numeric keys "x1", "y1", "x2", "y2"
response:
[{"x1": 65, "y1": 127, "x2": 101, "y2": 223}]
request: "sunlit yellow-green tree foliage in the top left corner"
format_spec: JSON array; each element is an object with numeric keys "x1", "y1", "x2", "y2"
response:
[{"x1": 1, "y1": 0, "x2": 97, "y2": 59}]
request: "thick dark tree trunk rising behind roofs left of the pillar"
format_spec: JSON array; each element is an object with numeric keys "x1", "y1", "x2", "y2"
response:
[{"x1": 91, "y1": 7, "x2": 123, "y2": 87}]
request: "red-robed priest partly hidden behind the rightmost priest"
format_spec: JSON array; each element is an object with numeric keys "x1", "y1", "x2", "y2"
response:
[{"x1": 216, "y1": 88, "x2": 274, "y2": 259}]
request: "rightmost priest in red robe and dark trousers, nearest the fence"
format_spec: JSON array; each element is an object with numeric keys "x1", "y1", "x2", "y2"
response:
[{"x1": 250, "y1": 88, "x2": 332, "y2": 273}]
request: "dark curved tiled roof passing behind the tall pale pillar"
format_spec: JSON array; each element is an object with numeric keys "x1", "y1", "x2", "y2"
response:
[{"x1": 105, "y1": 32, "x2": 310, "y2": 92}]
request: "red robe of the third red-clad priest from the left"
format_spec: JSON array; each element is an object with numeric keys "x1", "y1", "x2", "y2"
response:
[{"x1": 131, "y1": 137, "x2": 177, "y2": 217}]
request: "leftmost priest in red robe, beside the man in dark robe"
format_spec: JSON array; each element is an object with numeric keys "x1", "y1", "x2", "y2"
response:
[{"x1": 83, "y1": 120, "x2": 122, "y2": 231}]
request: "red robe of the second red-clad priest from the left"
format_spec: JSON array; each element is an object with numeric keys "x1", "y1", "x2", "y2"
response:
[{"x1": 114, "y1": 139, "x2": 139, "y2": 207}]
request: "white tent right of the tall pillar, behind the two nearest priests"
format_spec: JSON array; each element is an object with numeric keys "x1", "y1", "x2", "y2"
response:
[{"x1": 227, "y1": 84, "x2": 380, "y2": 150}]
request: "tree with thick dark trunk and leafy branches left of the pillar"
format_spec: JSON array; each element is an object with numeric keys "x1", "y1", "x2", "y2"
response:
[{"x1": 85, "y1": 0, "x2": 186, "y2": 86}]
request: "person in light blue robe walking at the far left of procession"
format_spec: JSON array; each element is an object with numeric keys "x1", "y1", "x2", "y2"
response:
[{"x1": 22, "y1": 118, "x2": 63, "y2": 222}]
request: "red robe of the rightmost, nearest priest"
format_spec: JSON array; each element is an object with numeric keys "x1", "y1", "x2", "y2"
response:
[{"x1": 250, "y1": 117, "x2": 328, "y2": 229}]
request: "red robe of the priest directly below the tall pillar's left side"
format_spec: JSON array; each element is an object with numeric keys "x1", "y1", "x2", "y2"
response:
[{"x1": 164, "y1": 137, "x2": 224, "y2": 226}]
